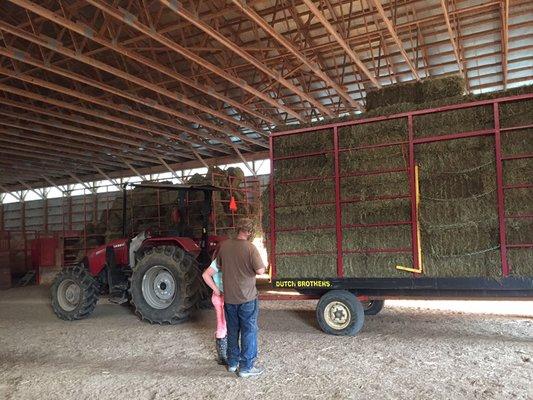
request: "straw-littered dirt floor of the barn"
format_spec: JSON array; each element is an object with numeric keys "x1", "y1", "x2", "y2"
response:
[{"x1": 0, "y1": 287, "x2": 533, "y2": 400}]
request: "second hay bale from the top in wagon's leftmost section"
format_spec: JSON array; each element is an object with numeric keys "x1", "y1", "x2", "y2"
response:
[{"x1": 274, "y1": 154, "x2": 334, "y2": 182}]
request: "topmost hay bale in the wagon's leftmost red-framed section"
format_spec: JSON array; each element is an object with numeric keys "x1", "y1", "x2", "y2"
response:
[{"x1": 273, "y1": 129, "x2": 333, "y2": 157}]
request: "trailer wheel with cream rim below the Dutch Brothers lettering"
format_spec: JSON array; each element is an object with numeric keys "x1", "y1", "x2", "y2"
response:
[{"x1": 316, "y1": 290, "x2": 365, "y2": 336}]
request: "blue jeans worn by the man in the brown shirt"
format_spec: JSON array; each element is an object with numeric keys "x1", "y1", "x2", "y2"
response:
[{"x1": 224, "y1": 299, "x2": 259, "y2": 371}]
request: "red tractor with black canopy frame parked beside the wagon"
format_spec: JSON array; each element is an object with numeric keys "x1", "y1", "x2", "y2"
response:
[{"x1": 52, "y1": 184, "x2": 225, "y2": 324}]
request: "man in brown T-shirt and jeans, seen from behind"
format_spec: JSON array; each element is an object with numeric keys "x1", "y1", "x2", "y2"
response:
[{"x1": 217, "y1": 218, "x2": 266, "y2": 377}]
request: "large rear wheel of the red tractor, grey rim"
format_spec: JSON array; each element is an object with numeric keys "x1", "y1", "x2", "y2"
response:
[{"x1": 129, "y1": 246, "x2": 201, "y2": 324}]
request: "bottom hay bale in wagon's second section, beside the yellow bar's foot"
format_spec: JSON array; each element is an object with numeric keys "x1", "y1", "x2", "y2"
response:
[{"x1": 342, "y1": 253, "x2": 413, "y2": 278}]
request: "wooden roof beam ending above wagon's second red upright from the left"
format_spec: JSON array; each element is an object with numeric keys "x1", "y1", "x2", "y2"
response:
[{"x1": 159, "y1": 0, "x2": 333, "y2": 117}]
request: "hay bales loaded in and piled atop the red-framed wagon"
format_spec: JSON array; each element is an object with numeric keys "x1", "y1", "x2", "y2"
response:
[{"x1": 263, "y1": 77, "x2": 533, "y2": 278}]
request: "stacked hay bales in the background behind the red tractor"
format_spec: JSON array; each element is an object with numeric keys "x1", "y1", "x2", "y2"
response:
[{"x1": 74, "y1": 167, "x2": 260, "y2": 258}]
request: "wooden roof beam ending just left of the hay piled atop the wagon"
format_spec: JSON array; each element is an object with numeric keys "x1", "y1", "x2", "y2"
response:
[{"x1": 232, "y1": 0, "x2": 362, "y2": 110}]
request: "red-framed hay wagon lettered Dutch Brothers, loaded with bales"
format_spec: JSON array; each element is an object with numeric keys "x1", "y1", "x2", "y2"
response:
[{"x1": 265, "y1": 93, "x2": 533, "y2": 335}]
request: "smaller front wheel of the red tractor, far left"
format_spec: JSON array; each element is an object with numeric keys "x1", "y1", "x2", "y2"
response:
[{"x1": 52, "y1": 264, "x2": 100, "y2": 321}]
